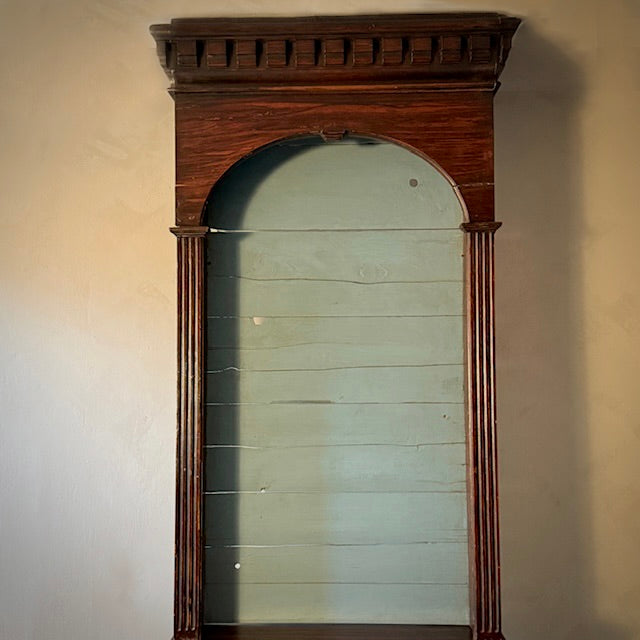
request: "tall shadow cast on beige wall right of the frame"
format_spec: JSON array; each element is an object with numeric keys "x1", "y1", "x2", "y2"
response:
[{"x1": 495, "y1": 23, "x2": 632, "y2": 640}]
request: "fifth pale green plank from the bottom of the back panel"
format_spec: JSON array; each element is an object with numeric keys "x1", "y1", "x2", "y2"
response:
[{"x1": 206, "y1": 404, "x2": 464, "y2": 447}]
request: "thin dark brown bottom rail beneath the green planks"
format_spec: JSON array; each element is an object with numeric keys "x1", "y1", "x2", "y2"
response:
[{"x1": 203, "y1": 624, "x2": 471, "y2": 640}]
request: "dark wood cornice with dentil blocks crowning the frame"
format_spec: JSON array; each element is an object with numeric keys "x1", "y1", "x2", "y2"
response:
[{"x1": 151, "y1": 13, "x2": 520, "y2": 93}]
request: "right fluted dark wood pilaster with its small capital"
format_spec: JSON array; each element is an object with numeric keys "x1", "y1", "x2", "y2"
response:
[{"x1": 462, "y1": 222, "x2": 503, "y2": 640}]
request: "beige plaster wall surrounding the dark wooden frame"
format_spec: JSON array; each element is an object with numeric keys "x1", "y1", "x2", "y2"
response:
[{"x1": 0, "y1": 0, "x2": 640, "y2": 640}]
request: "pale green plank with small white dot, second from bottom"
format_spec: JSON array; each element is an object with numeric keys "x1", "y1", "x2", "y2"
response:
[{"x1": 205, "y1": 542, "x2": 468, "y2": 585}]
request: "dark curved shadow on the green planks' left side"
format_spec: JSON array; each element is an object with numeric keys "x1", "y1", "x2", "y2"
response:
[{"x1": 204, "y1": 137, "x2": 332, "y2": 623}]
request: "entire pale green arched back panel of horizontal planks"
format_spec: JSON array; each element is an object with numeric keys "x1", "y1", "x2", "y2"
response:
[{"x1": 205, "y1": 139, "x2": 469, "y2": 624}]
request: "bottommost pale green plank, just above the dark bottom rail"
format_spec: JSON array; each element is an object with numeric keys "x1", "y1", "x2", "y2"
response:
[{"x1": 205, "y1": 584, "x2": 469, "y2": 624}]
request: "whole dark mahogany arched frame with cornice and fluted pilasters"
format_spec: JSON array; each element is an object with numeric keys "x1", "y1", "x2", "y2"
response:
[{"x1": 151, "y1": 13, "x2": 520, "y2": 640}]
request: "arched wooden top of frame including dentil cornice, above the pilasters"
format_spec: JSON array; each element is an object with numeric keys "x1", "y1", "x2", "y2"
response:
[{"x1": 151, "y1": 13, "x2": 520, "y2": 227}]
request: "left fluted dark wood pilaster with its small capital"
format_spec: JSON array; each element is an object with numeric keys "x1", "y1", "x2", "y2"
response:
[{"x1": 171, "y1": 227, "x2": 207, "y2": 640}]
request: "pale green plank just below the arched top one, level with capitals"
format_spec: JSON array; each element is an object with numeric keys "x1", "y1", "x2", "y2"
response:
[{"x1": 208, "y1": 229, "x2": 462, "y2": 284}]
